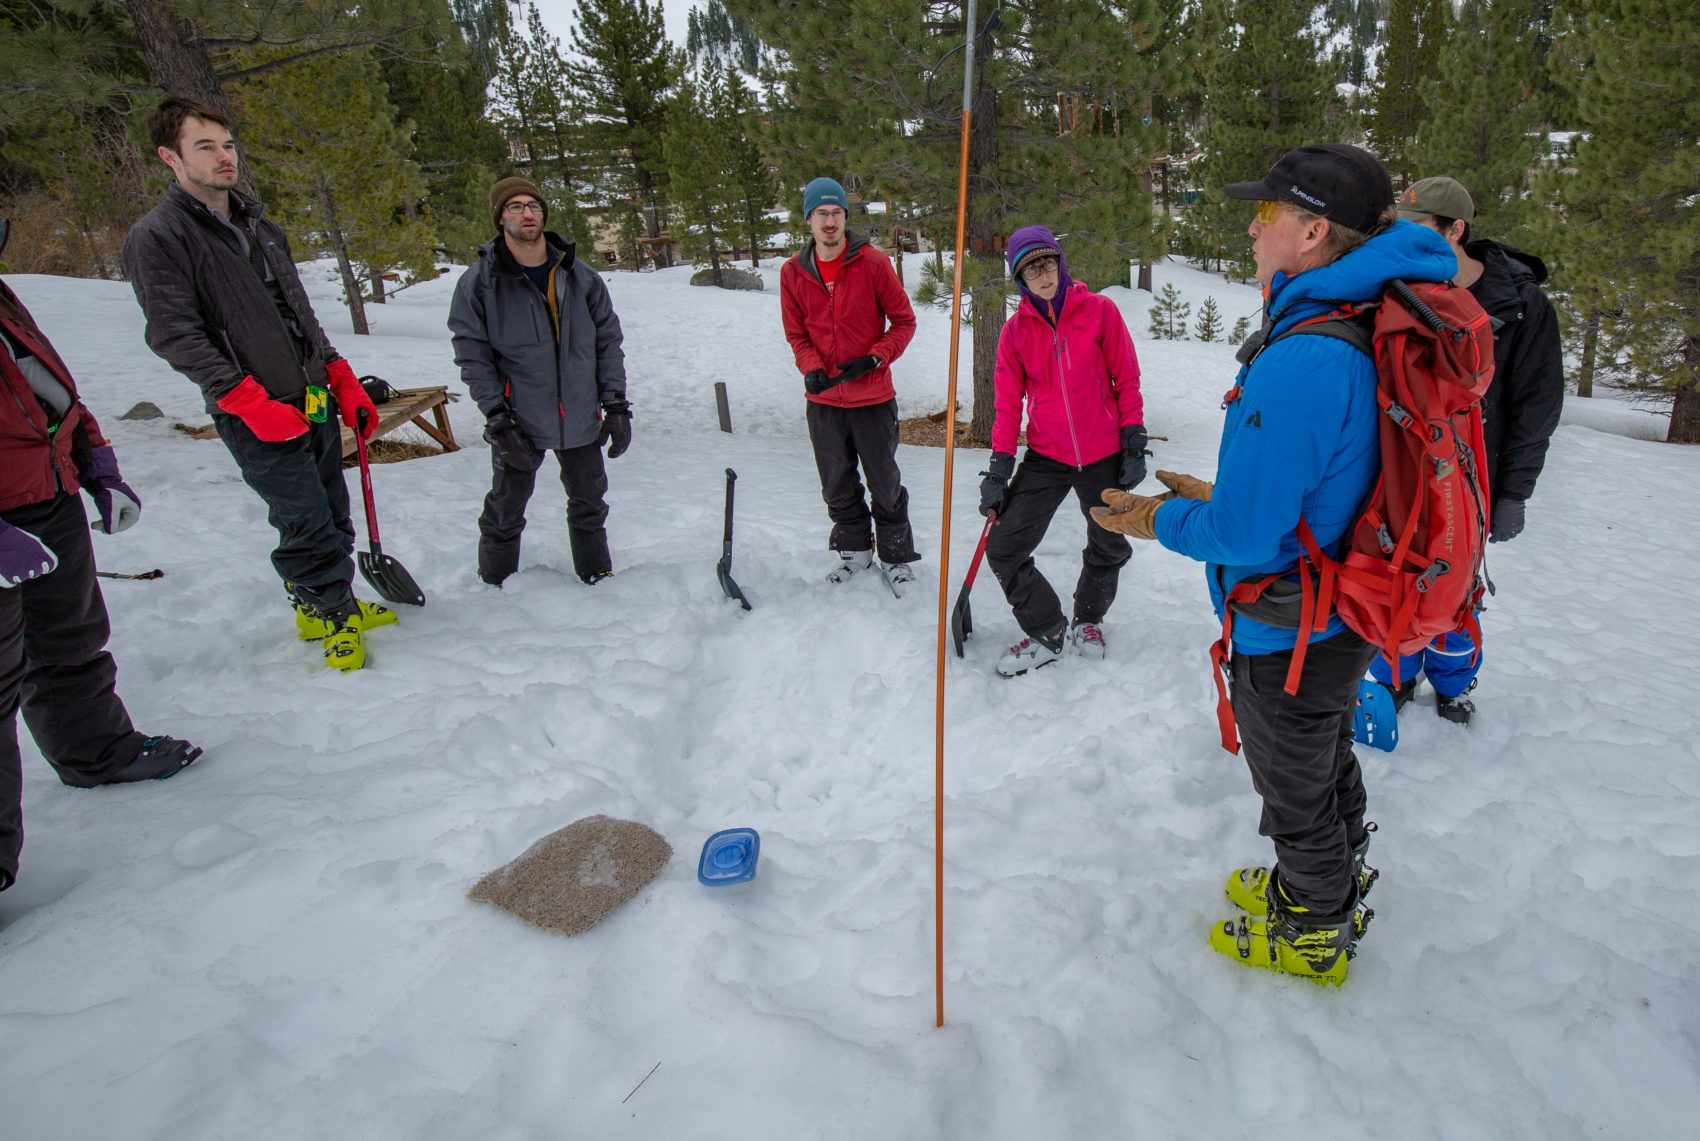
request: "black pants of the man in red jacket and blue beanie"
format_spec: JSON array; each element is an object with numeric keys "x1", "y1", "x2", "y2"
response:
[{"x1": 809, "y1": 400, "x2": 921, "y2": 563}]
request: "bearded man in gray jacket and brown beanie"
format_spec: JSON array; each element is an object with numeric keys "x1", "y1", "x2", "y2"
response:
[{"x1": 449, "y1": 179, "x2": 632, "y2": 587}]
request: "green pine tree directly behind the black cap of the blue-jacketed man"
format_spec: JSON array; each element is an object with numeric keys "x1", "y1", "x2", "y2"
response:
[{"x1": 1185, "y1": 0, "x2": 1338, "y2": 279}]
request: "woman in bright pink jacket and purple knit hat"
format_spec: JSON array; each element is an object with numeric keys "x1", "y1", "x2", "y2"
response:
[{"x1": 979, "y1": 226, "x2": 1149, "y2": 677}]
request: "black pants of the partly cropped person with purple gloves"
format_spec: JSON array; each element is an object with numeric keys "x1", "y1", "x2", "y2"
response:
[{"x1": 0, "y1": 495, "x2": 143, "y2": 876}]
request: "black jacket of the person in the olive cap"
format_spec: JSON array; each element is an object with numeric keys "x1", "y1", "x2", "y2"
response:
[{"x1": 1464, "y1": 241, "x2": 1564, "y2": 500}]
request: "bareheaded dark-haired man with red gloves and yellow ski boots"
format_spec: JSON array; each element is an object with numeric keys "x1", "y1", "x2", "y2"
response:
[{"x1": 124, "y1": 97, "x2": 396, "y2": 672}]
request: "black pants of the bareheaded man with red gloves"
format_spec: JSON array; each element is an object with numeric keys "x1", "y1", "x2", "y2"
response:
[{"x1": 213, "y1": 413, "x2": 354, "y2": 617}]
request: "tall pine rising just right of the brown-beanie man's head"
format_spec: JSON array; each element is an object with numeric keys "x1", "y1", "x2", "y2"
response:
[{"x1": 566, "y1": 0, "x2": 685, "y2": 264}]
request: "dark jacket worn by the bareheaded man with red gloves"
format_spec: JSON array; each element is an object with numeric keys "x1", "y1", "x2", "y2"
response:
[{"x1": 124, "y1": 182, "x2": 337, "y2": 412}]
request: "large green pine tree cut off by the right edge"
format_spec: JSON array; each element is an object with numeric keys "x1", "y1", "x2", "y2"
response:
[{"x1": 1559, "y1": 0, "x2": 1700, "y2": 444}]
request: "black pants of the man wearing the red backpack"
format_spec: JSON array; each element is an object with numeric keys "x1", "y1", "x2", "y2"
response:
[{"x1": 1231, "y1": 631, "x2": 1375, "y2": 915}]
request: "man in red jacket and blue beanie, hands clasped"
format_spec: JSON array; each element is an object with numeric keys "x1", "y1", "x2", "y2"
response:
[{"x1": 779, "y1": 179, "x2": 920, "y2": 592}]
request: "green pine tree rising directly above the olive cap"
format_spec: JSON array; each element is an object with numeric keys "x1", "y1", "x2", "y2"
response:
[{"x1": 1411, "y1": 0, "x2": 1545, "y2": 247}]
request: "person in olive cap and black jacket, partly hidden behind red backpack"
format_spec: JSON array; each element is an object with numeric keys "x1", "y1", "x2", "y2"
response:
[{"x1": 1370, "y1": 175, "x2": 1564, "y2": 724}]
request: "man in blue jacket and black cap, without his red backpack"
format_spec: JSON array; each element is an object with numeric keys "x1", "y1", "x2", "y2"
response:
[{"x1": 1093, "y1": 145, "x2": 1457, "y2": 985}]
